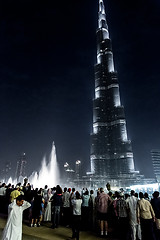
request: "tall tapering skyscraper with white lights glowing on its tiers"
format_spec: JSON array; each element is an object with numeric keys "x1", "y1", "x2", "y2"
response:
[{"x1": 90, "y1": 0, "x2": 135, "y2": 176}]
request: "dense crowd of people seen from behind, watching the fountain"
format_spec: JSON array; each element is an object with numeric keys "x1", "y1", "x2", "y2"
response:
[{"x1": 0, "y1": 183, "x2": 160, "y2": 240}]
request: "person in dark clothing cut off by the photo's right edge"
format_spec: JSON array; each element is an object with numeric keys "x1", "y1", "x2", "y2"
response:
[{"x1": 151, "y1": 191, "x2": 160, "y2": 240}]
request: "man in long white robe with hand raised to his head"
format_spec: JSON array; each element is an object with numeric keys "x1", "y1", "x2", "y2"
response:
[{"x1": 2, "y1": 195, "x2": 31, "y2": 240}]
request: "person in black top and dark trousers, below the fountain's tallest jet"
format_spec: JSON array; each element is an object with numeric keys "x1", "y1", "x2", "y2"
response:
[{"x1": 50, "y1": 185, "x2": 63, "y2": 228}]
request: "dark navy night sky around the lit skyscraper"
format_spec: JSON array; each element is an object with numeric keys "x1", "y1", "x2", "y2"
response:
[{"x1": 0, "y1": 0, "x2": 160, "y2": 177}]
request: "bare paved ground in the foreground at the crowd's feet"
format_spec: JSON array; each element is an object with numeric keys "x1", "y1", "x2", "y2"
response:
[{"x1": 0, "y1": 215, "x2": 118, "y2": 240}]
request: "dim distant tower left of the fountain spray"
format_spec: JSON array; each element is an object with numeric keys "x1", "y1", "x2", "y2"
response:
[{"x1": 15, "y1": 153, "x2": 27, "y2": 179}]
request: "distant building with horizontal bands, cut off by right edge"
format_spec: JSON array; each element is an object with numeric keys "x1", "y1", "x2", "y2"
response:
[{"x1": 151, "y1": 149, "x2": 160, "y2": 182}]
